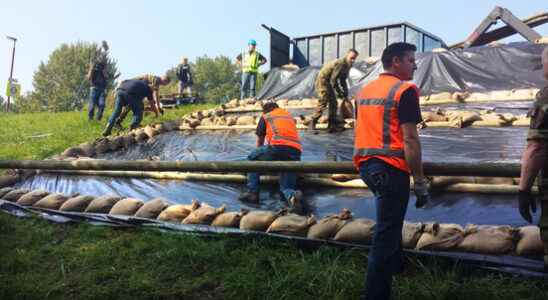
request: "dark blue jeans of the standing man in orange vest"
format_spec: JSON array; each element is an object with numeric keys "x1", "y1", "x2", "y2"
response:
[{"x1": 360, "y1": 158, "x2": 409, "y2": 300}]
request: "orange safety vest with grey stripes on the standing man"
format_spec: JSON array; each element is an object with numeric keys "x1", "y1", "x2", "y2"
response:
[{"x1": 354, "y1": 74, "x2": 419, "y2": 173}]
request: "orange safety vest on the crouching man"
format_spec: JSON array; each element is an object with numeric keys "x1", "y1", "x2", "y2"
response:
[{"x1": 263, "y1": 108, "x2": 302, "y2": 151}]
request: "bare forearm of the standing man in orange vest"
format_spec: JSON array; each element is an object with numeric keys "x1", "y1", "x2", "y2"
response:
[{"x1": 401, "y1": 123, "x2": 424, "y2": 182}]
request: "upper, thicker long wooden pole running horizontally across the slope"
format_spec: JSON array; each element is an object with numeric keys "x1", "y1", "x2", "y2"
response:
[{"x1": 0, "y1": 159, "x2": 520, "y2": 177}]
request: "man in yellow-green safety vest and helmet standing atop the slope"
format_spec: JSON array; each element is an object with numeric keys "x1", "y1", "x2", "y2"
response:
[{"x1": 236, "y1": 39, "x2": 266, "y2": 99}]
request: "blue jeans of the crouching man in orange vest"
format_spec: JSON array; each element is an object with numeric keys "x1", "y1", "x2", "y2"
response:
[{"x1": 247, "y1": 145, "x2": 301, "y2": 200}]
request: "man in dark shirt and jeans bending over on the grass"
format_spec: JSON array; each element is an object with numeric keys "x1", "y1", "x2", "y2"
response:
[{"x1": 103, "y1": 79, "x2": 158, "y2": 136}]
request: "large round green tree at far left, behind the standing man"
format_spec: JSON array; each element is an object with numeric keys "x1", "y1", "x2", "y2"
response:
[{"x1": 29, "y1": 41, "x2": 117, "y2": 111}]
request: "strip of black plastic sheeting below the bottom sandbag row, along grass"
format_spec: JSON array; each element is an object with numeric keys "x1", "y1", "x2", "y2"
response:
[{"x1": 0, "y1": 200, "x2": 548, "y2": 278}]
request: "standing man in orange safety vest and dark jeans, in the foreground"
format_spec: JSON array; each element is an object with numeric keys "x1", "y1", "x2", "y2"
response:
[{"x1": 354, "y1": 43, "x2": 430, "y2": 300}]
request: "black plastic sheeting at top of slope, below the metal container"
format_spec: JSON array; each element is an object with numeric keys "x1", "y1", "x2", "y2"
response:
[{"x1": 257, "y1": 42, "x2": 546, "y2": 99}]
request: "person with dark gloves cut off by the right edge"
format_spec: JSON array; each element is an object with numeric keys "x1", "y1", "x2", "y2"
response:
[{"x1": 519, "y1": 47, "x2": 548, "y2": 270}]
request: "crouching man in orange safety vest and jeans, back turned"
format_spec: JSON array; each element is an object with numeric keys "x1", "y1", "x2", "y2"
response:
[{"x1": 238, "y1": 102, "x2": 302, "y2": 213}]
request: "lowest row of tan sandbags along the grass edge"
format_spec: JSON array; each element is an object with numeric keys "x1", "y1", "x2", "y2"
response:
[{"x1": 0, "y1": 187, "x2": 544, "y2": 255}]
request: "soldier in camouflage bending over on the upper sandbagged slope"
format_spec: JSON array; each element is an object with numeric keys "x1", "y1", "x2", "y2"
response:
[{"x1": 310, "y1": 49, "x2": 358, "y2": 132}]
